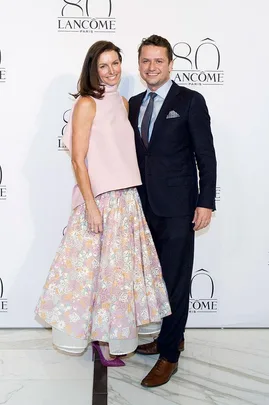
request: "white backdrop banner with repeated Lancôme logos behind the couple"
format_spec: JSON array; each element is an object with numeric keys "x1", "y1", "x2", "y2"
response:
[{"x1": 0, "y1": 0, "x2": 269, "y2": 327}]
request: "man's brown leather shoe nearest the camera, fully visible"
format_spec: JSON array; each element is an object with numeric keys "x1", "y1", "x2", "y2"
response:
[{"x1": 141, "y1": 357, "x2": 178, "y2": 388}]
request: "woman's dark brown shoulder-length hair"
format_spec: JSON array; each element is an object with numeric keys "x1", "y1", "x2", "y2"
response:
[{"x1": 71, "y1": 41, "x2": 122, "y2": 99}]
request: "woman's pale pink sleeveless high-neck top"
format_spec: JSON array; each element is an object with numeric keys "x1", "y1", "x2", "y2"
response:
[{"x1": 63, "y1": 86, "x2": 142, "y2": 208}]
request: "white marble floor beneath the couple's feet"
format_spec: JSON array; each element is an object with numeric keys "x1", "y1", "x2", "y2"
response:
[{"x1": 0, "y1": 329, "x2": 269, "y2": 405}]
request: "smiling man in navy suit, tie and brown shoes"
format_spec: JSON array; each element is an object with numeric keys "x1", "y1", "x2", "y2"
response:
[{"x1": 129, "y1": 35, "x2": 216, "y2": 387}]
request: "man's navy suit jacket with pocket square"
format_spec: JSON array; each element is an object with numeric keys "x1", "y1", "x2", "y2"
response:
[{"x1": 129, "y1": 82, "x2": 216, "y2": 217}]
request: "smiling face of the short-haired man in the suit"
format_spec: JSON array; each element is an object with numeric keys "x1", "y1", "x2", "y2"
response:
[{"x1": 139, "y1": 45, "x2": 173, "y2": 91}]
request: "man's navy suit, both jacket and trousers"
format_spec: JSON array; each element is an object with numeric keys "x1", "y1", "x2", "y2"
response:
[{"x1": 129, "y1": 82, "x2": 216, "y2": 362}]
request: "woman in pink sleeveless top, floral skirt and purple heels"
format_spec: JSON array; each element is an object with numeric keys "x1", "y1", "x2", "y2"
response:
[{"x1": 36, "y1": 41, "x2": 171, "y2": 366}]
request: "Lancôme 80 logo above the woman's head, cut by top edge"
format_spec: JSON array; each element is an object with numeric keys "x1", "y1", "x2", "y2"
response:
[{"x1": 58, "y1": 0, "x2": 116, "y2": 33}]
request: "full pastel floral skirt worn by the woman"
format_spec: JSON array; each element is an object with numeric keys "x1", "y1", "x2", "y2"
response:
[{"x1": 36, "y1": 188, "x2": 171, "y2": 354}]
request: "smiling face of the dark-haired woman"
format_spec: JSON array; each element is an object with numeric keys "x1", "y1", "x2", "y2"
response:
[{"x1": 97, "y1": 51, "x2": 121, "y2": 86}]
